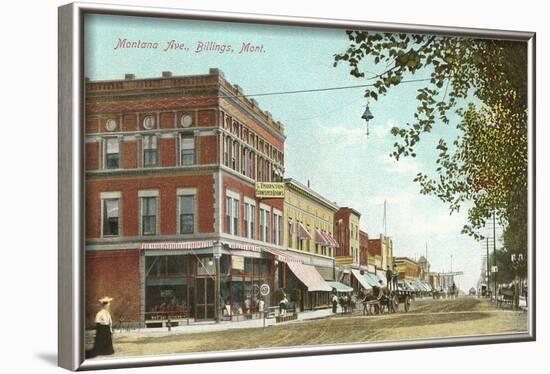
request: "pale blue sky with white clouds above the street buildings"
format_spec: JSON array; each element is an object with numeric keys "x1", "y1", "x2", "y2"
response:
[{"x1": 85, "y1": 15, "x2": 500, "y2": 290}]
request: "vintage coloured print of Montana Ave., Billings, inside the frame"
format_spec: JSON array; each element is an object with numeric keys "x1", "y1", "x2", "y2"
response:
[{"x1": 78, "y1": 8, "x2": 533, "y2": 361}]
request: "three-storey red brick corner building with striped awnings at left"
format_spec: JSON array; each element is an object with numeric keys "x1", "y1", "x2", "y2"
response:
[{"x1": 85, "y1": 69, "x2": 285, "y2": 325}]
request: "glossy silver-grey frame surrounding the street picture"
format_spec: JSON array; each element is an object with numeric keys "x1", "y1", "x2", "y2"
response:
[{"x1": 58, "y1": 3, "x2": 536, "y2": 370}]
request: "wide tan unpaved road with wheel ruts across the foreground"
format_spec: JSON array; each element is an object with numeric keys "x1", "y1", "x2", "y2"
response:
[{"x1": 89, "y1": 297, "x2": 527, "y2": 359}]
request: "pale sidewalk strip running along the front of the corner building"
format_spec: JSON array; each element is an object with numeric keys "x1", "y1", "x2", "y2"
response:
[{"x1": 103, "y1": 309, "x2": 335, "y2": 337}]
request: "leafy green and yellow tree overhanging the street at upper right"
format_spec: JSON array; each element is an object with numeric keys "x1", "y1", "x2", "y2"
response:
[{"x1": 334, "y1": 31, "x2": 527, "y2": 243}]
